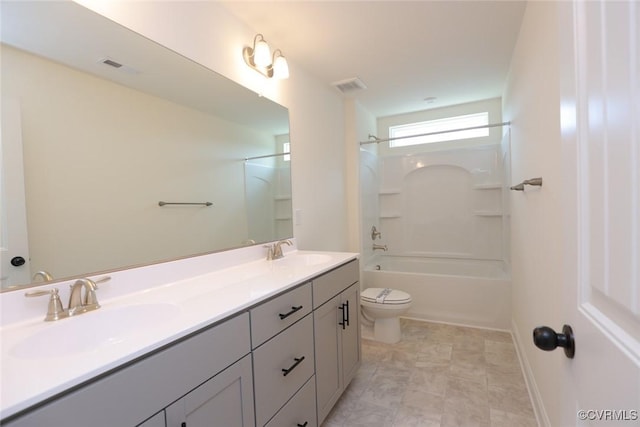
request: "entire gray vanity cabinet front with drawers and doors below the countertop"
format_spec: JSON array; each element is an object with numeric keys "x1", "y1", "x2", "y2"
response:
[{"x1": 2, "y1": 260, "x2": 360, "y2": 427}]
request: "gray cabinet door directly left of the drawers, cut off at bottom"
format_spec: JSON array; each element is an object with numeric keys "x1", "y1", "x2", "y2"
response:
[{"x1": 165, "y1": 356, "x2": 255, "y2": 427}]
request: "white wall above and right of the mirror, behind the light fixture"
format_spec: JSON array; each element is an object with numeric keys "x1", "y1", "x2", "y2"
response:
[{"x1": 78, "y1": 0, "x2": 349, "y2": 250}]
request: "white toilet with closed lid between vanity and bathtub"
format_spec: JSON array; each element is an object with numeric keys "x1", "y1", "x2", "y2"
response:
[{"x1": 360, "y1": 288, "x2": 411, "y2": 344}]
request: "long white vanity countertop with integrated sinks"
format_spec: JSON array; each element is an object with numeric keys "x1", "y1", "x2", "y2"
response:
[{"x1": 0, "y1": 251, "x2": 358, "y2": 419}]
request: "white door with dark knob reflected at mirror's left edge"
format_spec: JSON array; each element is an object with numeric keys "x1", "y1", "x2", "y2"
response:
[{"x1": 0, "y1": 98, "x2": 31, "y2": 288}]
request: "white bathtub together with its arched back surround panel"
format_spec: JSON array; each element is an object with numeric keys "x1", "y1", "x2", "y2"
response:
[{"x1": 363, "y1": 140, "x2": 511, "y2": 329}]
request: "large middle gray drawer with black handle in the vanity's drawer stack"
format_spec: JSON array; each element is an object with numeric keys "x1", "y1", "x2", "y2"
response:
[{"x1": 253, "y1": 315, "x2": 315, "y2": 426}]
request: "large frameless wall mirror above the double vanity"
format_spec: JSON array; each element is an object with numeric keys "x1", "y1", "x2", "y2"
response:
[{"x1": 0, "y1": 2, "x2": 293, "y2": 289}]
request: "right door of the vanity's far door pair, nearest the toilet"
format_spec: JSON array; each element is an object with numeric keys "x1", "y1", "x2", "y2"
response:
[{"x1": 340, "y1": 283, "x2": 361, "y2": 388}]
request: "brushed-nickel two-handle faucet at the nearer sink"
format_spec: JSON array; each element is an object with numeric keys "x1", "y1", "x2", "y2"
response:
[{"x1": 24, "y1": 276, "x2": 111, "y2": 321}]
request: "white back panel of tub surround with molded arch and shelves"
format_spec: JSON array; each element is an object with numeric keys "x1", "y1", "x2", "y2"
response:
[{"x1": 379, "y1": 145, "x2": 504, "y2": 261}]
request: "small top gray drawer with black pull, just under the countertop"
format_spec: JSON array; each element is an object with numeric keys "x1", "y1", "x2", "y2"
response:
[{"x1": 250, "y1": 282, "x2": 311, "y2": 348}]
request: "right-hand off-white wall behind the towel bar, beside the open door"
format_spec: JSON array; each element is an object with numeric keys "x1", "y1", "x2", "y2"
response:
[{"x1": 503, "y1": 1, "x2": 566, "y2": 426}]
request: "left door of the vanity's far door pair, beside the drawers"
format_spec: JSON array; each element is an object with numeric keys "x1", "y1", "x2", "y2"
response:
[{"x1": 313, "y1": 295, "x2": 343, "y2": 425}]
